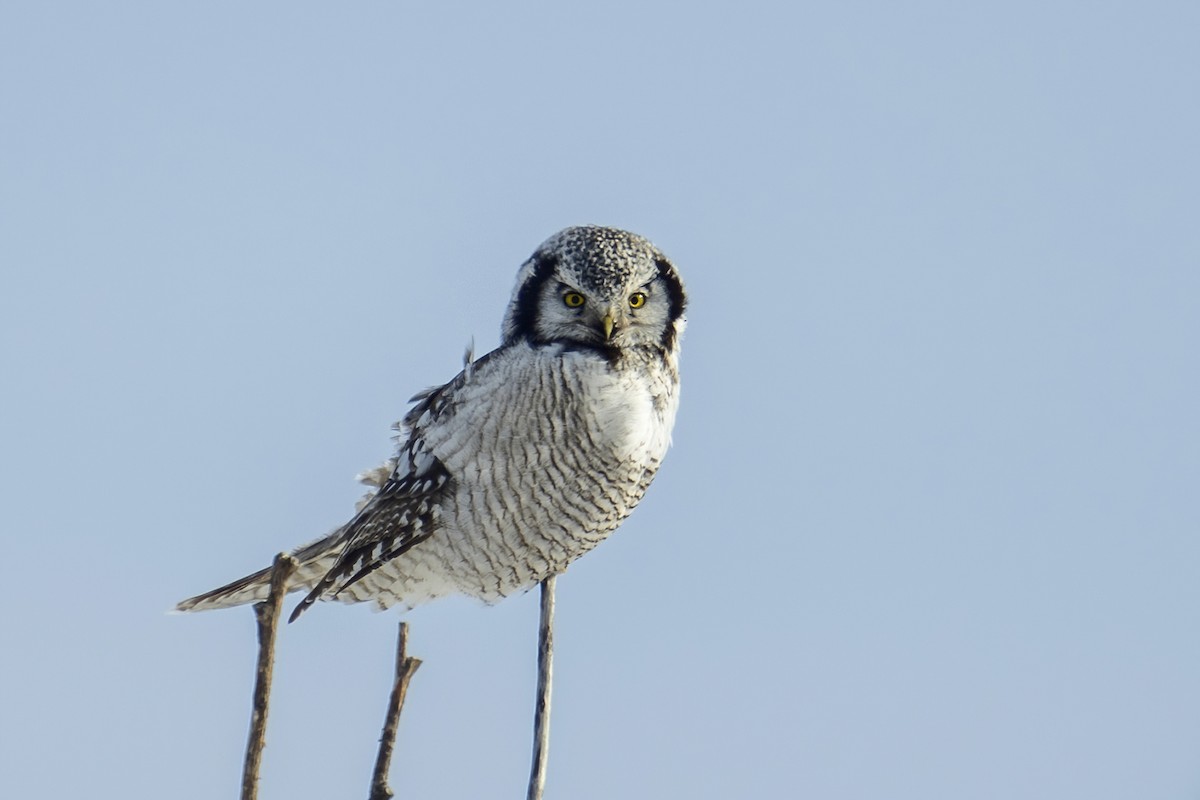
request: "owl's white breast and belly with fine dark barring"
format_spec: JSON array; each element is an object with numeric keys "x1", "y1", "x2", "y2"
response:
[{"x1": 405, "y1": 345, "x2": 674, "y2": 600}]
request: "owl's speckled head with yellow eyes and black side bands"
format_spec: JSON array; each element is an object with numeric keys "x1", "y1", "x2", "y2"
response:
[{"x1": 503, "y1": 225, "x2": 688, "y2": 354}]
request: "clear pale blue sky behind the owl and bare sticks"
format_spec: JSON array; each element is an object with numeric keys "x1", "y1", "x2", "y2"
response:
[{"x1": 0, "y1": 0, "x2": 1200, "y2": 800}]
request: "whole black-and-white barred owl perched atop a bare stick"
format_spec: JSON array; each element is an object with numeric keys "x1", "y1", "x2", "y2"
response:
[{"x1": 178, "y1": 225, "x2": 686, "y2": 619}]
